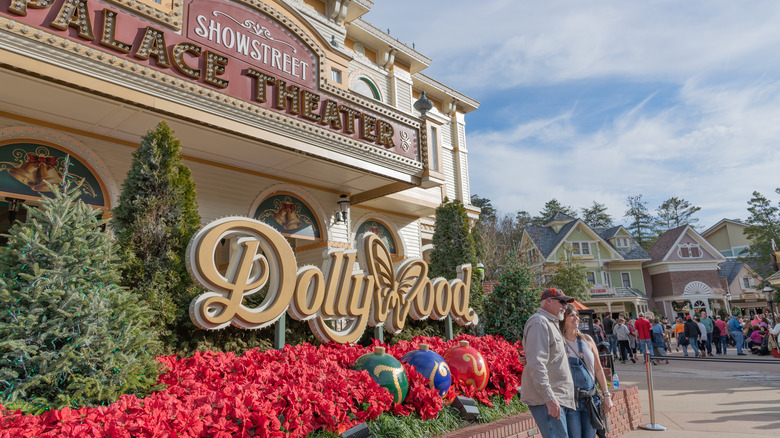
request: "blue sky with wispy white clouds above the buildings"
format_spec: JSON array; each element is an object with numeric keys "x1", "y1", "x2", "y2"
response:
[{"x1": 363, "y1": 0, "x2": 780, "y2": 229}]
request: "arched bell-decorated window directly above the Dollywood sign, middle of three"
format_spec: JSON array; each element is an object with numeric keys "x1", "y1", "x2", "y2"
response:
[{"x1": 249, "y1": 184, "x2": 330, "y2": 241}]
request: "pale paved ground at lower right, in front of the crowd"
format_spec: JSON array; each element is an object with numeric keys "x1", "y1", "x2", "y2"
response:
[{"x1": 616, "y1": 348, "x2": 780, "y2": 438}]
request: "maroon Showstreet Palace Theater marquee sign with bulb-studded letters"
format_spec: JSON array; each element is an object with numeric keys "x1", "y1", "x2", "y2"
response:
[{"x1": 0, "y1": 0, "x2": 420, "y2": 161}]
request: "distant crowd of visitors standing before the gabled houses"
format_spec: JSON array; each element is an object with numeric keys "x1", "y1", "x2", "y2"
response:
[{"x1": 594, "y1": 311, "x2": 780, "y2": 365}]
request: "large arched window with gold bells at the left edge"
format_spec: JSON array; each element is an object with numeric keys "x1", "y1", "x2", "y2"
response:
[{"x1": 0, "y1": 126, "x2": 119, "y2": 210}]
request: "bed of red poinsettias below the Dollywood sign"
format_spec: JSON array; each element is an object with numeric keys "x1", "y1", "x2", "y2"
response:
[{"x1": 0, "y1": 335, "x2": 522, "y2": 438}]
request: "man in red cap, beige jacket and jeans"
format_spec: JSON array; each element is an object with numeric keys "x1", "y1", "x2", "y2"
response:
[{"x1": 520, "y1": 289, "x2": 576, "y2": 438}]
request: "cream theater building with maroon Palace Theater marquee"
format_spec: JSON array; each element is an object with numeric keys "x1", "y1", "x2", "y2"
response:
[{"x1": 0, "y1": 0, "x2": 478, "y2": 265}]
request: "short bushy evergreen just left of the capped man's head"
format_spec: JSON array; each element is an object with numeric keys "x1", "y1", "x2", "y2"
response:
[{"x1": 485, "y1": 254, "x2": 540, "y2": 342}]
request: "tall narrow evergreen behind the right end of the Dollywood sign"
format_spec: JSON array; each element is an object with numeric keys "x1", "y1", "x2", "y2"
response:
[{"x1": 428, "y1": 199, "x2": 483, "y2": 328}]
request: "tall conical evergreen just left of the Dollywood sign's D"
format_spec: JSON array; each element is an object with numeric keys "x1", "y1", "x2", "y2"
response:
[{"x1": 112, "y1": 122, "x2": 200, "y2": 349}]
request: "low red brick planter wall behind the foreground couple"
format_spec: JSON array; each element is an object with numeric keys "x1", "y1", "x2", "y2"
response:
[{"x1": 443, "y1": 386, "x2": 642, "y2": 438}]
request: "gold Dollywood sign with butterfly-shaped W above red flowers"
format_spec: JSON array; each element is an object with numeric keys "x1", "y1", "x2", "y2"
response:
[{"x1": 186, "y1": 217, "x2": 478, "y2": 343}]
